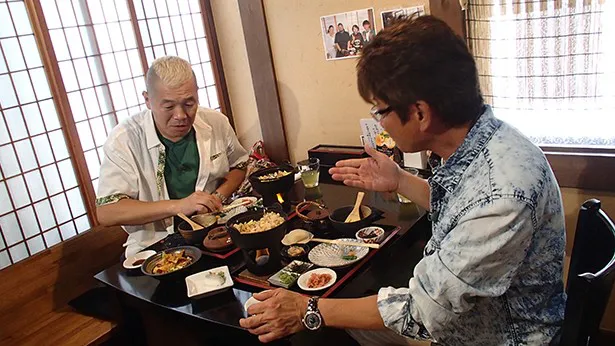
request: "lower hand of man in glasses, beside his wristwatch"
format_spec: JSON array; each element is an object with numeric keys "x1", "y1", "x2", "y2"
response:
[{"x1": 239, "y1": 288, "x2": 308, "y2": 342}]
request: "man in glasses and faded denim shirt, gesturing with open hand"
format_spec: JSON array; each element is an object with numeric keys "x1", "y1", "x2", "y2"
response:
[{"x1": 240, "y1": 16, "x2": 566, "y2": 345}]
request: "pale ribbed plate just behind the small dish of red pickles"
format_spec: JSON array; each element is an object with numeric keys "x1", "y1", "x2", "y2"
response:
[{"x1": 308, "y1": 238, "x2": 369, "y2": 268}]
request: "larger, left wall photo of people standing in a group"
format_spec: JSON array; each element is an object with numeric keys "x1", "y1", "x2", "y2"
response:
[{"x1": 320, "y1": 8, "x2": 376, "y2": 60}]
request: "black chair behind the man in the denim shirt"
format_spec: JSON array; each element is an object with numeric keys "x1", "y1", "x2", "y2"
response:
[{"x1": 560, "y1": 199, "x2": 615, "y2": 346}]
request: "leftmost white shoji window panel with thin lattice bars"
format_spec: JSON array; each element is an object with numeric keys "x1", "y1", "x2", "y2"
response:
[{"x1": 0, "y1": 1, "x2": 89, "y2": 268}]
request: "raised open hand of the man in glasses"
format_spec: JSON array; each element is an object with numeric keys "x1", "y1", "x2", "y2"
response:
[{"x1": 329, "y1": 145, "x2": 401, "y2": 192}]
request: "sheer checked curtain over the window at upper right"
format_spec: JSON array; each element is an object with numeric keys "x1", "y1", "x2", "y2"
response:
[{"x1": 466, "y1": 0, "x2": 615, "y2": 147}]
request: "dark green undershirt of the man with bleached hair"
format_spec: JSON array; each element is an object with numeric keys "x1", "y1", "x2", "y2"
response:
[{"x1": 156, "y1": 128, "x2": 200, "y2": 199}]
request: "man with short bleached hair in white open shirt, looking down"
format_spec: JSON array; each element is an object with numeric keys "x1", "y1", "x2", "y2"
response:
[{"x1": 96, "y1": 56, "x2": 248, "y2": 255}]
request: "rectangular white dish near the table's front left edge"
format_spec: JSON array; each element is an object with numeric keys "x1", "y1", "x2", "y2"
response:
[{"x1": 186, "y1": 266, "x2": 233, "y2": 298}]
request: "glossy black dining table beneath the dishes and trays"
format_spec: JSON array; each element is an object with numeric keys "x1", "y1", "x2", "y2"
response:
[{"x1": 95, "y1": 182, "x2": 429, "y2": 343}]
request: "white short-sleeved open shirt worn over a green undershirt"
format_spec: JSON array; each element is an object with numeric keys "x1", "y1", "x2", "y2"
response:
[{"x1": 96, "y1": 107, "x2": 248, "y2": 255}]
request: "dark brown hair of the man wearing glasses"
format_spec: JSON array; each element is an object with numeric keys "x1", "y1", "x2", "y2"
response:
[{"x1": 357, "y1": 16, "x2": 483, "y2": 126}]
